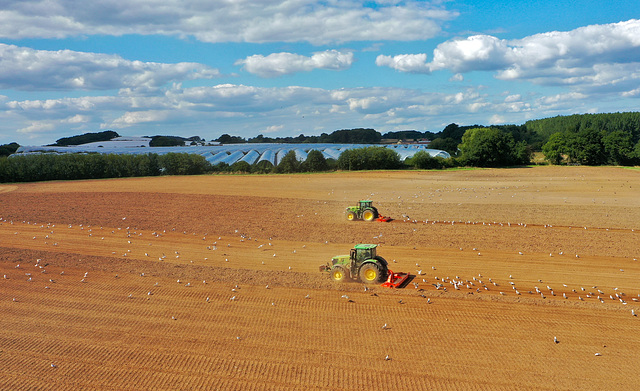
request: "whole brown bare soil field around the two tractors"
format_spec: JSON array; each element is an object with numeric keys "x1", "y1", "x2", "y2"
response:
[{"x1": 0, "y1": 167, "x2": 640, "y2": 390}]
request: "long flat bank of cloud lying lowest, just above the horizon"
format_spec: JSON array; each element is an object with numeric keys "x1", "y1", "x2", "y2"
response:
[{"x1": 0, "y1": 84, "x2": 616, "y2": 144}]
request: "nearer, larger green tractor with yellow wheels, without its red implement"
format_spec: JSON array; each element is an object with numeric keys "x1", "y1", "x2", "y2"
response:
[{"x1": 320, "y1": 244, "x2": 389, "y2": 284}]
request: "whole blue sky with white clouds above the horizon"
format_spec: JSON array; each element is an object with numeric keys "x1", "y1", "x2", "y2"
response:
[{"x1": 0, "y1": 0, "x2": 640, "y2": 145}]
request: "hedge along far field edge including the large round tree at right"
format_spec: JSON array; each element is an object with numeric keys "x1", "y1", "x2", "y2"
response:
[{"x1": 0, "y1": 133, "x2": 530, "y2": 182}]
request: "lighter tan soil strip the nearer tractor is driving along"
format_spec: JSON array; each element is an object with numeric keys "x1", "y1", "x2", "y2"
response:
[{"x1": 0, "y1": 222, "x2": 640, "y2": 301}]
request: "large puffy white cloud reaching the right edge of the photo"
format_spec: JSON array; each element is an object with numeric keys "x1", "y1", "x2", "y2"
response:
[{"x1": 376, "y1": 19, "x2": 640, "y2": 94}]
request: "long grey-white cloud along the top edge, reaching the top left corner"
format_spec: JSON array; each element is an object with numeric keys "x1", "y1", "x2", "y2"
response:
[{"x1": 0, "y1": 0, "x2": 457, "y2": 44}]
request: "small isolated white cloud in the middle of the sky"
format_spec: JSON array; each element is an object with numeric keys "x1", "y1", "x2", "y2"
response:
[{"x1": 235, "y1": 50, "x2": 353, "y2": 77}]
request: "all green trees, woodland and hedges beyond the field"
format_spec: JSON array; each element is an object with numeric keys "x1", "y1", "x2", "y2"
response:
[{"x1": 0, "y1": 112, "x2": 640, "y2": 182}]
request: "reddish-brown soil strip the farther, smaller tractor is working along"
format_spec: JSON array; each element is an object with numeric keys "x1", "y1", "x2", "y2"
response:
[{"x1": 0, "y1": 192, "x2": 640, "y2": 258}]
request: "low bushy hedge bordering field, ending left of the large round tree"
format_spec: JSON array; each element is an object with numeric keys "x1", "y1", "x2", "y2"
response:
[{"x1": 0, "y1": 146, "x2": 459, "y2": 183}]
